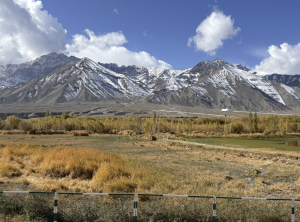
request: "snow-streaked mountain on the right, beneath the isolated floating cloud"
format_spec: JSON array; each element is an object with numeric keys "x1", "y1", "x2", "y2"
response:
[{"x1": 145, "y1": 59, "x2": 300, "y2": 111}]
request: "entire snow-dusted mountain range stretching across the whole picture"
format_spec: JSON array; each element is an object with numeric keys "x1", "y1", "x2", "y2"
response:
[{"x1": 0, "y1": 53, "x2": 300, "y2": 111}]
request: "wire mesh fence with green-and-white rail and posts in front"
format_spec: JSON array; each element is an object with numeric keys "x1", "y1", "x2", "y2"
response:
[{"x1": 0, "y1": 191, "x2": 300, "y2": 222}]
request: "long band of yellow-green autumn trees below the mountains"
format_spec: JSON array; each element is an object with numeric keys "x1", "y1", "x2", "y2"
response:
[{"x1": 0, "y1": 112, "x2": 300, "y2": 134}]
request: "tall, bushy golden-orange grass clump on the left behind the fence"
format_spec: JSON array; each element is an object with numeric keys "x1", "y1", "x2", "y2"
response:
[{"x1": 0, "y1": 144, "x2": 159, "y2": 192}]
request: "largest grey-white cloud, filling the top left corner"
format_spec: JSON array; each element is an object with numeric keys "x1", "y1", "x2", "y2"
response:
[{"x1": 0, "y1": 0, "x2": 66, "y2": 65}]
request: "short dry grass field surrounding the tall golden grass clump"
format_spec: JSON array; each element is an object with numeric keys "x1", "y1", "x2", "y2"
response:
[{"x1": 0, "y1": 134, "x2": 300, "y2": 198}]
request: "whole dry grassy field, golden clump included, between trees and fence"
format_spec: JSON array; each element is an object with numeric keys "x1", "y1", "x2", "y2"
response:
[{"x1": 0, "y1": 134, "x2": 300, "y2": 198}]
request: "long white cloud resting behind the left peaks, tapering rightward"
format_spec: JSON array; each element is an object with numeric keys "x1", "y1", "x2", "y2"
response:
[{"x1": 66, "y1": 29, "x2": 172, "y2": 69}]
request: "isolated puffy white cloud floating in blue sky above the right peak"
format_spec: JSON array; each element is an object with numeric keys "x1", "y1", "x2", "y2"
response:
[{"x1": 188, "y1": 10, "x2": 241, "y2": 56}]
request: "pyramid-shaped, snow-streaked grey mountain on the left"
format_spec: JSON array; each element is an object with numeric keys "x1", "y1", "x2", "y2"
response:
[{"x1": 0, "y1": 58, "x2": 151, "y2": 104}]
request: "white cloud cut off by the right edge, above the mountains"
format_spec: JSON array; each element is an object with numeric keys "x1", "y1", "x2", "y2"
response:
[{"x1": 255, "y1": 43, "x2": 300, "y2": 75}]
